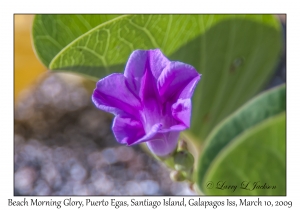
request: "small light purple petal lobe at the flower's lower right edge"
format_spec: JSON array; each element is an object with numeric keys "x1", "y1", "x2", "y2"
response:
[{"x1": 172, "y1": 98, "x2": 192, "y2": 128}]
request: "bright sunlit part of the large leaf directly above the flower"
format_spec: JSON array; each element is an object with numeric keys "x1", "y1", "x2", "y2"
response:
[{"x1": 49, "y1": 15, "x2": 241, "y2": 80}]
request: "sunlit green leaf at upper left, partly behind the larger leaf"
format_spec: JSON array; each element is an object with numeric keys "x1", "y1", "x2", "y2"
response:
[{"x1": 32, "y1": 15, "x2": 119, "y2": 67}]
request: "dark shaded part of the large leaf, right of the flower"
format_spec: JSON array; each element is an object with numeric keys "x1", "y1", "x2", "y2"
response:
[{"x1": 184, "y1": 16, "x2": 282, "y2": 141}]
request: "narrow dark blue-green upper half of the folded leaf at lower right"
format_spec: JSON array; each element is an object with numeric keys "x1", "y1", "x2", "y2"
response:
[{"x1": 196, "y1": 85, "x2": 286, "y2": 195}]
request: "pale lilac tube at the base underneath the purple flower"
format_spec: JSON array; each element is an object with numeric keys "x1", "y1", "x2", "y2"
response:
[{"x1": 147, "y1": 131, "x2": 180, "y2": 156}]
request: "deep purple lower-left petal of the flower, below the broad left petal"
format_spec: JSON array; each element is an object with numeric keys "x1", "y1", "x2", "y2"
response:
[{"x1": 112, "y1": 115, "x2": 145, "y2": 145}]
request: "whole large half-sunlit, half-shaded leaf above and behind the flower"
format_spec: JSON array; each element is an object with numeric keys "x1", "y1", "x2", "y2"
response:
[{"x1": 33, "y1": 15, "x2": 281, "y2": 142}]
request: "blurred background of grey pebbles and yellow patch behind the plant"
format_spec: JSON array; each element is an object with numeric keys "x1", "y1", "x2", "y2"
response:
[{"x1": 14, "y1": 15, "x2": 286, "y2": 195}]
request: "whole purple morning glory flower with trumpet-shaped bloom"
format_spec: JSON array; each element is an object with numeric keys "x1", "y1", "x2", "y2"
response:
[{"x1": 92, "y1": 49, "x2": 201, "y2": 156}]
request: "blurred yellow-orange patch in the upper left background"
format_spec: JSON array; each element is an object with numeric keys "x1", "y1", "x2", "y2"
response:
[{"x1": 14, "y1": 15, "x2": 46, "y2": 100}]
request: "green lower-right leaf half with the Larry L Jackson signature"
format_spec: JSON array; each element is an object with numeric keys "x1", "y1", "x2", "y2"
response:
[{"x1": 202, "y1": 112, "x2": 286, "y2": 195}]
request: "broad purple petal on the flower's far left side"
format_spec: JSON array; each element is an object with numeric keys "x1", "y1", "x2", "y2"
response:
[{"x1": 92, "y1": 74, "x2": 141, "y2": 116}]
